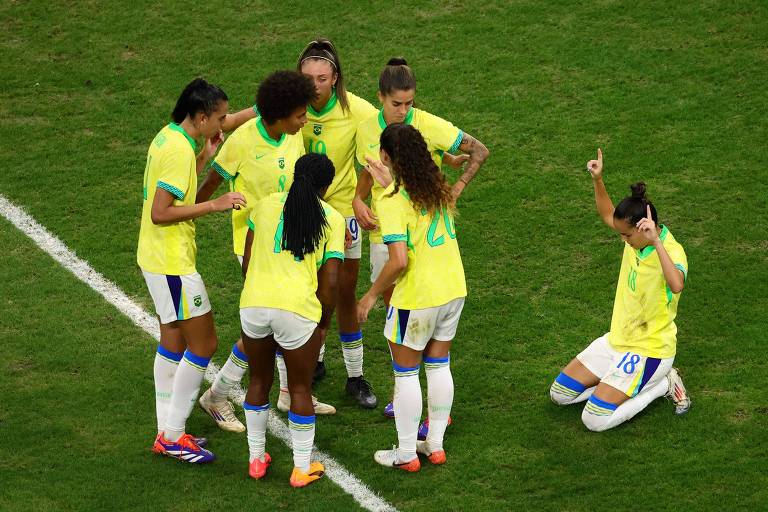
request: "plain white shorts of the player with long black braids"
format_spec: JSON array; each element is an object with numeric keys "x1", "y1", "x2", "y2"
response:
[{"x1": 240, "y1": 308, "x2": 317, "y2": 350}]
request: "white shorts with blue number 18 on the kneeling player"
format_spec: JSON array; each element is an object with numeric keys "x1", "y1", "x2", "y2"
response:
[{"x1": 576, "y1": 334, "x2": 675, "y2": 398}]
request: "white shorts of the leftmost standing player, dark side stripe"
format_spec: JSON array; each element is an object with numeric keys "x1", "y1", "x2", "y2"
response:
[{"x1": 141, "y1": 270, "x2": 211, "y2": 324}]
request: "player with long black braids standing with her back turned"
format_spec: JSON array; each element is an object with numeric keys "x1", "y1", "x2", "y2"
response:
[{"x1": 240, "y1": 153, "x2": 345, "y2": 487}]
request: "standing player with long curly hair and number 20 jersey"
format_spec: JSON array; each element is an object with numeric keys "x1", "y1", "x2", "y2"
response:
[{"x1": 358, "y1": 123, "x2": 471, "y2": 472}]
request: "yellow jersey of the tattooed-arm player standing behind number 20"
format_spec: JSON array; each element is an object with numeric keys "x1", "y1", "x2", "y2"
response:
[{"x1": 356, "y1": 108, "x2": 464, "y2": 244}]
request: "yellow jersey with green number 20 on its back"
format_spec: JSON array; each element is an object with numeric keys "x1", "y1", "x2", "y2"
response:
[{"x1": 379, "y1": 184, "x2": 467, "y2": 309}]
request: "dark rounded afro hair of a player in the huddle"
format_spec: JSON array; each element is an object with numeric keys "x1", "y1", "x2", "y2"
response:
[{"x1": 256, "y1": 71, "x2": 317, "y2": 124}]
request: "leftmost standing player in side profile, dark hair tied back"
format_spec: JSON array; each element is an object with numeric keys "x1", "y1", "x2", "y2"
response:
[{"x1": 136, "y1": 78, "x2": 245, "y2": 463}]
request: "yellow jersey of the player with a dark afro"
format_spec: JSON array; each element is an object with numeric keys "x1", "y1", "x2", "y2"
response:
[{"x1": 213, "y1": 117, "x2": 304, "y2": 256}]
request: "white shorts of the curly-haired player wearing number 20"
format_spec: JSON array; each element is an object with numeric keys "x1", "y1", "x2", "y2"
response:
[{"x1": 384, "y1": 297, "x2": 464, "y2": 351}]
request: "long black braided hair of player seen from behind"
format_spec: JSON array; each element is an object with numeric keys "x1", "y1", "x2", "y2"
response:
[{"x1": 282, "y1": 153, "x2": 336, "y2": 259}]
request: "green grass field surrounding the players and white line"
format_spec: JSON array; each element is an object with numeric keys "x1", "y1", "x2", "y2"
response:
[{"x1": 0, "y1": 0, "x2": 768, "y2": 511}]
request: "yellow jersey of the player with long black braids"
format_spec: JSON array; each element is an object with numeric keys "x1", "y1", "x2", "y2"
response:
[{"x1": 240, "y1": 192, "x2": 345, "y2": 322}]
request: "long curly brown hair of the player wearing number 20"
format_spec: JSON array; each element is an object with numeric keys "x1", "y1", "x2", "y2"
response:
[{"x1": 379, "y1": 123, "x2": 454, "y2": 215}]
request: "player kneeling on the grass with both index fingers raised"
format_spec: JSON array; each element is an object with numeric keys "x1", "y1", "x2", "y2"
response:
[{"x1": 550, "y1": 149, "x2": 691, "y2": 432}]
